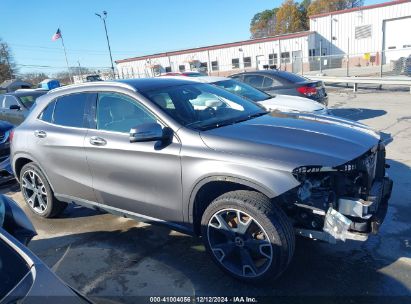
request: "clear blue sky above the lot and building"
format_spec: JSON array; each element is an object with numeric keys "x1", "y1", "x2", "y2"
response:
[{"x1": 0, "y1": 0, "x2": 386, "y2": 75}]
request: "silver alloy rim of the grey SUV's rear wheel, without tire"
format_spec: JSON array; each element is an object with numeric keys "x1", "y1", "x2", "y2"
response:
[{"x1": 21, "y1": 170, "x2": 48, "y2": 214}]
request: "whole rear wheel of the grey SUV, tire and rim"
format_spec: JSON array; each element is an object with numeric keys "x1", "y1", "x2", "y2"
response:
[{"x1": 19, "y1": 163, "x2": 67, "y2": 218}]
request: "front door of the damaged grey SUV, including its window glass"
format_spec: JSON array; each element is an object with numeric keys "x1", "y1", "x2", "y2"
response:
[{"x1": 85, "y1": 92, "x2": 182, "y2": 222}]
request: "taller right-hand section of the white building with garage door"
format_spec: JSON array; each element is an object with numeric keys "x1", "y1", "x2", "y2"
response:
[{"x1": 310, "y1": 0, "x2": 411, "y2": 61}]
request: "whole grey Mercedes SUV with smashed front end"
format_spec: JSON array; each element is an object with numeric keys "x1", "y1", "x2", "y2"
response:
[{"x1": 12, "y1": 78, "x2": 392, "y2": 281}]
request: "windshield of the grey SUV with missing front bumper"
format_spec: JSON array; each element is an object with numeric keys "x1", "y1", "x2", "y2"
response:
[{"x1": 140, "y1": 84, "x2": 267, "y2": 130}]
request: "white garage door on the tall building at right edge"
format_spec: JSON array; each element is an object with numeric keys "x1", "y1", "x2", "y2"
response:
[{"x1": 384, "y1": 17, "x2": 411, "y2": 63}]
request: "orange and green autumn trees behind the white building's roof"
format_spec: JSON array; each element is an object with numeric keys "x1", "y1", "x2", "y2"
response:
[{"x1": 250, "y1": 0, "x2": 364, "y2": 38}]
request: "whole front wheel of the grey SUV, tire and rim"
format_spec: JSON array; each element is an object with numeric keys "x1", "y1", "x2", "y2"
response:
[{"x1": 201, "y1": 190, "x2": 295, "y2": 282}]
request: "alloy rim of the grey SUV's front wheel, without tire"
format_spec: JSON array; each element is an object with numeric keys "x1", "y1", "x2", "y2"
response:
[{"x1": 207, "y1": 209, "x2": 273, "y2": 277}]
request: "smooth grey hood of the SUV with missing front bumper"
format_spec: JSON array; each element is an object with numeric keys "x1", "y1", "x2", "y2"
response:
[{"x1": 200, "y1": 112, "x2": 380, "y2": 169}]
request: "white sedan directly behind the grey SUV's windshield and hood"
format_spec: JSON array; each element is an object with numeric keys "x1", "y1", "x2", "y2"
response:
[{"x1": 166, "y1": 76, "x2": 329, "y2": 115}]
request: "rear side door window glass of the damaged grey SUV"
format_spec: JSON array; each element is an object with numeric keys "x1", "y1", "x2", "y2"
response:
[{"x1": 53, "y1": 93, "x2": 94, "y2": 128}]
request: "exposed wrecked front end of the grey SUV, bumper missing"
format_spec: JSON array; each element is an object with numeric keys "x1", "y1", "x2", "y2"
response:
[{"x1": 280, "y1": 142, "x2": 392, "y2": 243}]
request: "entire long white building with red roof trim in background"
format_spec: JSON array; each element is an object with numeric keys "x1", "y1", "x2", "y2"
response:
[{"x1": 116, "y1": 0, "x2": 411, "y2": 78}]
